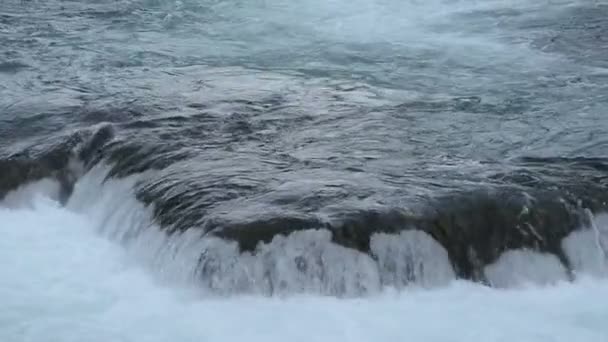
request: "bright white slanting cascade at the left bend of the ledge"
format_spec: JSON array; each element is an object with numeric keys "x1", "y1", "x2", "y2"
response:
[{"x1": 66, "y1": 165, "x2": 203, "y2": 284}]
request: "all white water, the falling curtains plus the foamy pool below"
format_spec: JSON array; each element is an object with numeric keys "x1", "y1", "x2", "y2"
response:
[{"x1": 0, "y1": 168, "x2": 608, "y2": 342}]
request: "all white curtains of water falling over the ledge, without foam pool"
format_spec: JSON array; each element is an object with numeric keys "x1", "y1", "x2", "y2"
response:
[{"x1": 4, "y1": 166, "x2": 608, "y2": 296}]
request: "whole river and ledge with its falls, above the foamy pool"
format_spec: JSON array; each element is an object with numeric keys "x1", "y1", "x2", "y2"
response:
[{"x1": 0, "y1": 0, "x2": 608, "y2": 296}]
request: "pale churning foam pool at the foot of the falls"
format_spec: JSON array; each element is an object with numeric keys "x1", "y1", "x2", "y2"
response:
[{"x1": 0, "y1": 178, "x2": 608, "y2": 342}]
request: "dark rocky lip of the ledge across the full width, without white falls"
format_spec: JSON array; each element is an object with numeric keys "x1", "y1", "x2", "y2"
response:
[{"x1": 0, "y1": 125, "x2": 608, "y2": 282}]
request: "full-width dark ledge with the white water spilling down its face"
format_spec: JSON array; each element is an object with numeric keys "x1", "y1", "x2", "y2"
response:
[{"x1": 3, "y1": 121, "x2": 608, "y2": 296}]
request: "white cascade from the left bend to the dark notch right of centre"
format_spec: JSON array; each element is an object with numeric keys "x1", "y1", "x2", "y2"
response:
[{"x1": 67, "y1": 166, "x2": 380, "y2": 295}]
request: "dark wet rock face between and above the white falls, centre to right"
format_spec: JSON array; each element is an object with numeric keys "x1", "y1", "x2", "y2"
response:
[{"x1": 195, "y1": 189, "x2": 604, "y2": 282}]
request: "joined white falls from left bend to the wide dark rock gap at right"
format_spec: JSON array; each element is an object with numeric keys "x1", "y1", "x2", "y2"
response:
[{"x1": 61, "y1": 165, "x2": 454, "y2": 296}]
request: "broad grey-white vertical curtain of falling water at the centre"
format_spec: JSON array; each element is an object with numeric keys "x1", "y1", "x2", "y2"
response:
[{"x1": 195, "y1": 230, "x2": 380, "y2": 296}]
